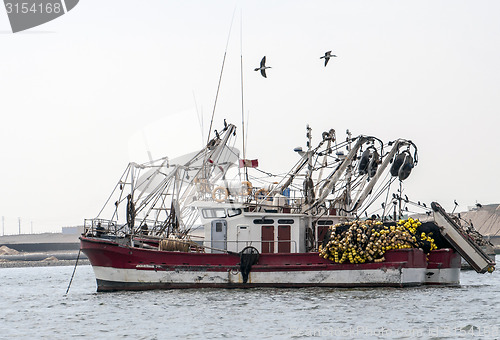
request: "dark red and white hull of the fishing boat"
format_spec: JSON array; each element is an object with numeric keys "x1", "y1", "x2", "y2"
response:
[{"x1": 81, "y1": 237, "x2": 460, "y2": 291}]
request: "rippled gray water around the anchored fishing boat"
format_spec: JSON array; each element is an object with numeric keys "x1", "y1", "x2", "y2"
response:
[{"x1": 0, "y1": 257, "x2": 500, "y2": 339}]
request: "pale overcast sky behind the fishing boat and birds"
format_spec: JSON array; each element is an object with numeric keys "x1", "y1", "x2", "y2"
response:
[{"x1": 0, "y1": 0, "x2": 500, "y2": 234}]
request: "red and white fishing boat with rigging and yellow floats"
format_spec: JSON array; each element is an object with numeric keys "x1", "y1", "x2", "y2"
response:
[{"x1": 80, "y1": 121, "x2": 494, "y2": 291}]
